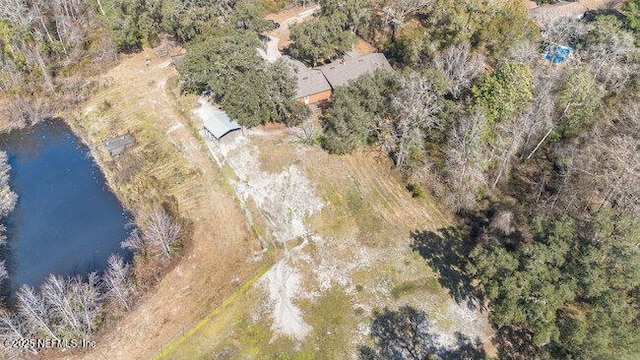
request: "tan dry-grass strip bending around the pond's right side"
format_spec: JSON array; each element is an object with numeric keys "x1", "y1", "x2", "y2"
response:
[{"x1": 59, "y1": 51, "x2": 261, "y2": 360}]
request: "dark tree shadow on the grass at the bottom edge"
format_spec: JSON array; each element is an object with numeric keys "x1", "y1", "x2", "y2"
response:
[{"x1": 360, "y1": 305, "x2": 486, "y2": 360}]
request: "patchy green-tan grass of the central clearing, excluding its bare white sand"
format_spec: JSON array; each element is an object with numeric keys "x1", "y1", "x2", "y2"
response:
[{"x1": 159, "y1": 127, "x2": 491, "y2": 359}]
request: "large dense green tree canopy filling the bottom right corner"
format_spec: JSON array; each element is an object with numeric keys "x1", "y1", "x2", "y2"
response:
[{"x1": 468, "y1": 209, "x2": 640, "y2": 358}]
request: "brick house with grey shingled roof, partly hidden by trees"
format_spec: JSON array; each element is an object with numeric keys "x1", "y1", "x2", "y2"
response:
[{"x1": 285, "y1": 53, "x2": 393, "y2": 104}]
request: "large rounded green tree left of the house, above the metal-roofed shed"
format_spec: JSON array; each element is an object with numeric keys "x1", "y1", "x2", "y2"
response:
[{"x1": 179, "y1": 32, "x2": 303, "y2": 126}]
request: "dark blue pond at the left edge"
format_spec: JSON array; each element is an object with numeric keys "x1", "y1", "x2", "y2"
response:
[{"x1": 0, "y1": 120, "x2": 130, "y2": 294}]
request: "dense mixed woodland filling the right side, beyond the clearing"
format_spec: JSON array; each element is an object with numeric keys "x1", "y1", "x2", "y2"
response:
[{"x1": 301, "y1": 0, "x2": 640, "y2": 359}]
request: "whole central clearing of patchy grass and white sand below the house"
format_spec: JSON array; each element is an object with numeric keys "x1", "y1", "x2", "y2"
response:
[{"x1": 160, "y1": 127, "x2": 491, "y2": 359}]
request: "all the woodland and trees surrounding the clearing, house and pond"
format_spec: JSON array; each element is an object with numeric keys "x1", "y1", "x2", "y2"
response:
[{"x1": 0, "y1": 0, "x2": 640, "y2": 359}]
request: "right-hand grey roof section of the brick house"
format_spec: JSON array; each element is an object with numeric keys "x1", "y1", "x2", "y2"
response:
[{"x1": 316, "y1": 53, "x2": 392, "y2": 89}]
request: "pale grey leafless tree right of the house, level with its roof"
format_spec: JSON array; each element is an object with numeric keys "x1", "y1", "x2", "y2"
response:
[{"x1": 433, "y1": 43, "x2": 484, "y2": 99}]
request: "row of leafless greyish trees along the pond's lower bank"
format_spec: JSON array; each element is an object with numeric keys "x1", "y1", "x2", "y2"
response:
[{"x1": 0, "y1": 207, "x2": 185, "y2": 358}]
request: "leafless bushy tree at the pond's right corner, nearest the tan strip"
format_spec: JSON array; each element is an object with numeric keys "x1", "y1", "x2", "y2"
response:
[{"x1": 142, "y1": 207, "x2": 182, "y2": 259}]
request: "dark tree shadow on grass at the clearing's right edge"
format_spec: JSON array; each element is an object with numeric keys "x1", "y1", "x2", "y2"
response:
[{"x1": 411, "y1": 226, "x2": 483, "y2": 309}]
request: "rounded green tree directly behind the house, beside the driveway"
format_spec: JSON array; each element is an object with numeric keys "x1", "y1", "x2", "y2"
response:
[{"x1": 289, "y1": 14, "x2": 355, "y2": 66}]
